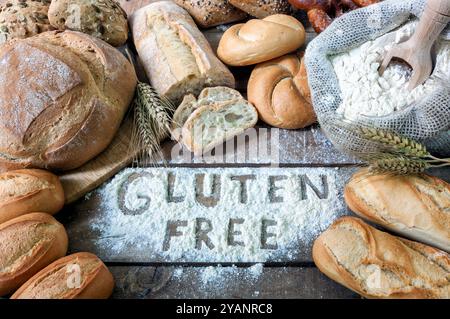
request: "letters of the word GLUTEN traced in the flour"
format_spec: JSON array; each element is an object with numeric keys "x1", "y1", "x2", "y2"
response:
[{"x1": 118, "y1": 172, "x2": 329, "y2": 215}]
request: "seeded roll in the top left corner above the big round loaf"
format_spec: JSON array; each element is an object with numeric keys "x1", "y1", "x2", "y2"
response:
[{"x1": 0, "y1": 0, "x2": 53, "y2": 44}]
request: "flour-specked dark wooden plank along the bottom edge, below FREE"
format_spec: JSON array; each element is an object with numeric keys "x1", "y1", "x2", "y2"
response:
[{"x1": 110, "y1": 266, "x2": 359, "y2": 299}]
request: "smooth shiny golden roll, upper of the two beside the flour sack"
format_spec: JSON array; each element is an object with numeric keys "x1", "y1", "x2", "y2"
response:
[{"x1": 217, "y1": 14, "x2": 305, "y2": 66}]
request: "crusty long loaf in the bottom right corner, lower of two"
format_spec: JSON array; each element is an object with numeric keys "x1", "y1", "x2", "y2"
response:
[{"x1": 313, "y1": 217, "x2": 450, "y2": 299}]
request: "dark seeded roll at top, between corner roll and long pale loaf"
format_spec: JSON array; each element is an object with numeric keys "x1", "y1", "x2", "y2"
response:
[{"x1": 48, "y1": 0, "x2": 128, "y2": 46}]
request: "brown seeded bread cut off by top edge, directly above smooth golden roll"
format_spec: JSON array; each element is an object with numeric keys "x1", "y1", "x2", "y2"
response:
[{"x1": 230, "y1": 0, "x2": 292, "y2": 19}]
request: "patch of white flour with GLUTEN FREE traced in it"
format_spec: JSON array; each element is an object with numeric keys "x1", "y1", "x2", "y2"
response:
[{"x1": 93, "y1": 168, "x2": 342, "y2": 262}]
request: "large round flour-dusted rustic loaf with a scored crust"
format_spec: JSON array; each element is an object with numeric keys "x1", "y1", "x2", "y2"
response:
[{"x1": 0, "y1": 31, "x2": 137, "y2": 171}]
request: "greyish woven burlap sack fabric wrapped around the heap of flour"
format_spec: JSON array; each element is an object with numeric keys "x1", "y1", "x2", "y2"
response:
[{"x1": 305, "y1": 0, "x2": 450, "y2": 156}]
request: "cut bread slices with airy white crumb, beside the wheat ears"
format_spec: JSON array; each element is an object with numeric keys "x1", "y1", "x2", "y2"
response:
[{"x1": 172, "y1": 87, "x2": 258, "y2": 155}]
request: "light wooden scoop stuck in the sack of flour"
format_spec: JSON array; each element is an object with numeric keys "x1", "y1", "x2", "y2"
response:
[{"x1": 379, "y1": 0, "x2": 450, "y2": 91}]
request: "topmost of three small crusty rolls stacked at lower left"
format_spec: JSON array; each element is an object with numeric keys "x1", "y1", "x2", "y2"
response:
[{"x1": 0, "y1": 169, "x2": 64, "y2": 224}]
